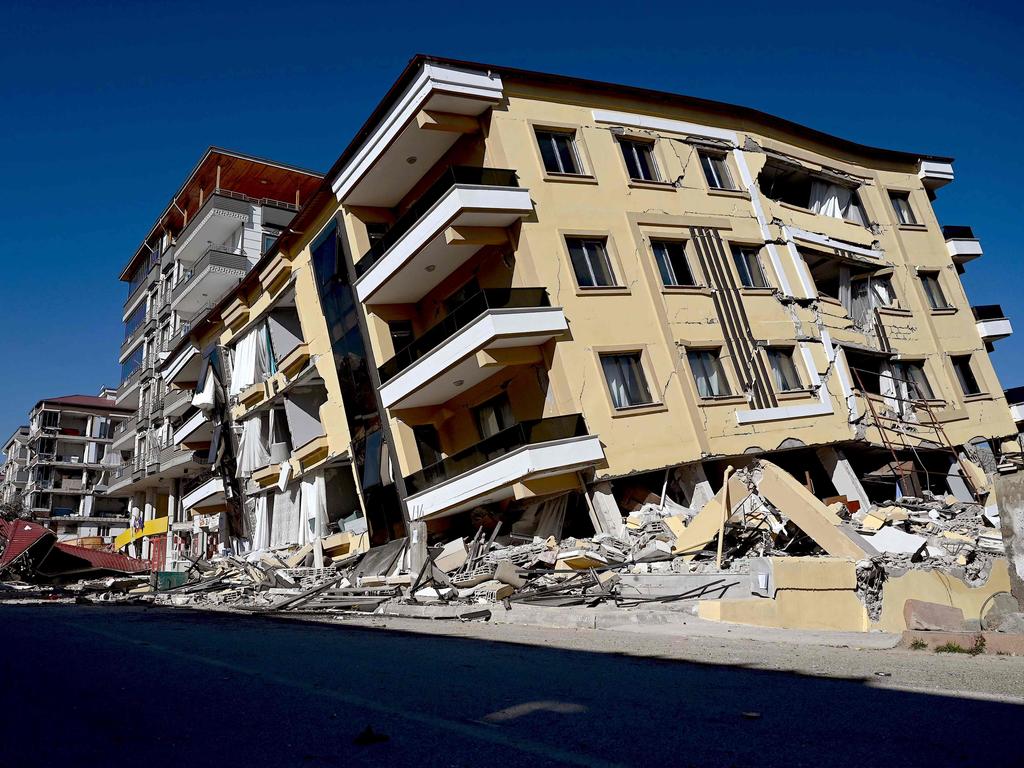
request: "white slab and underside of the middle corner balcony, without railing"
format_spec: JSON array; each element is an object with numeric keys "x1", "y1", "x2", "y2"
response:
[{"x1": 381, "y1": 307, "x2": 568, "y2": 415}]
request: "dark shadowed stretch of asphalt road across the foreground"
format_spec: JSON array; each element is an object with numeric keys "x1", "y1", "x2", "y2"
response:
[{"x1": 0, "y1": 606, "x2": 1024, "y2": 768}]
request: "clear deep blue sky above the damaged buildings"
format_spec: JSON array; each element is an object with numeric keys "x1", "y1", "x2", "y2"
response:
[{"x1": 0, "y1": 0, "x2": 1024, "y2": 439}]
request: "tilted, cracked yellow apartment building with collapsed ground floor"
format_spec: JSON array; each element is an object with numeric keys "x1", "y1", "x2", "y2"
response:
[{"x1": 155, "y1": 56, "x2": 1019, "y2": 565}]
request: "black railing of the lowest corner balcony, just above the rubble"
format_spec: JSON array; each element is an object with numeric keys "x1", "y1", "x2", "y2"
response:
[{"x1": 406, "y1": 414, "x2": 587, "y2": 494}]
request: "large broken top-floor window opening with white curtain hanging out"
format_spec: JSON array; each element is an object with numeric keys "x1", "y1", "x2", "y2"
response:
[{"x1": 758, "y1": 161, "x2": 867, "y2": 226}]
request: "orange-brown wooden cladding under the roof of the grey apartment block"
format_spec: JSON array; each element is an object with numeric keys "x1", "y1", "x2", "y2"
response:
[{"x1": 121, "y1": 150, "x2": 323, "y2": 280}]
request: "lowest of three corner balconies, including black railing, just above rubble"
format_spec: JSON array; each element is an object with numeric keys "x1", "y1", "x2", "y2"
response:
[{"x1": 406, "y1": 414, "x2": 604, "y2": 520}]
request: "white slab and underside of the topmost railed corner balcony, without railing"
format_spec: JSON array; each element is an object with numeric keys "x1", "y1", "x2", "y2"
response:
[{"x1": 355, "y1": 184, "x2": 534, "y2": 304}]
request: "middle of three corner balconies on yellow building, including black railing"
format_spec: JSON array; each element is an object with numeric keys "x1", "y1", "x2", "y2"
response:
[{"x1": 379, "y1": 288, "x2": 568, "y2": 408}]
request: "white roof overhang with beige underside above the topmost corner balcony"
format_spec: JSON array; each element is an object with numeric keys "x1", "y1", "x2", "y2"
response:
[{"x1": 331, "y1": 63, "x2": 503, "y2": 208}]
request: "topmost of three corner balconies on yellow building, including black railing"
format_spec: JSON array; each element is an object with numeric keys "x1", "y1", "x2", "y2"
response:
[{"x1": 355, "y1": 166, "x2": 534, "y2": 304}]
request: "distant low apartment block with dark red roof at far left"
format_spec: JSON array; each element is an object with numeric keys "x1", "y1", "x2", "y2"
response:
[{"x1": 19, "y1": 388, "x2": 129, "y2": 544}]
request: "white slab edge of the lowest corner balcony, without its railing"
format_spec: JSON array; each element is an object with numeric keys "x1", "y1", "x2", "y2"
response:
[{"x1": 408, "y1": 435, "x2": 604, "y2": 520}]
